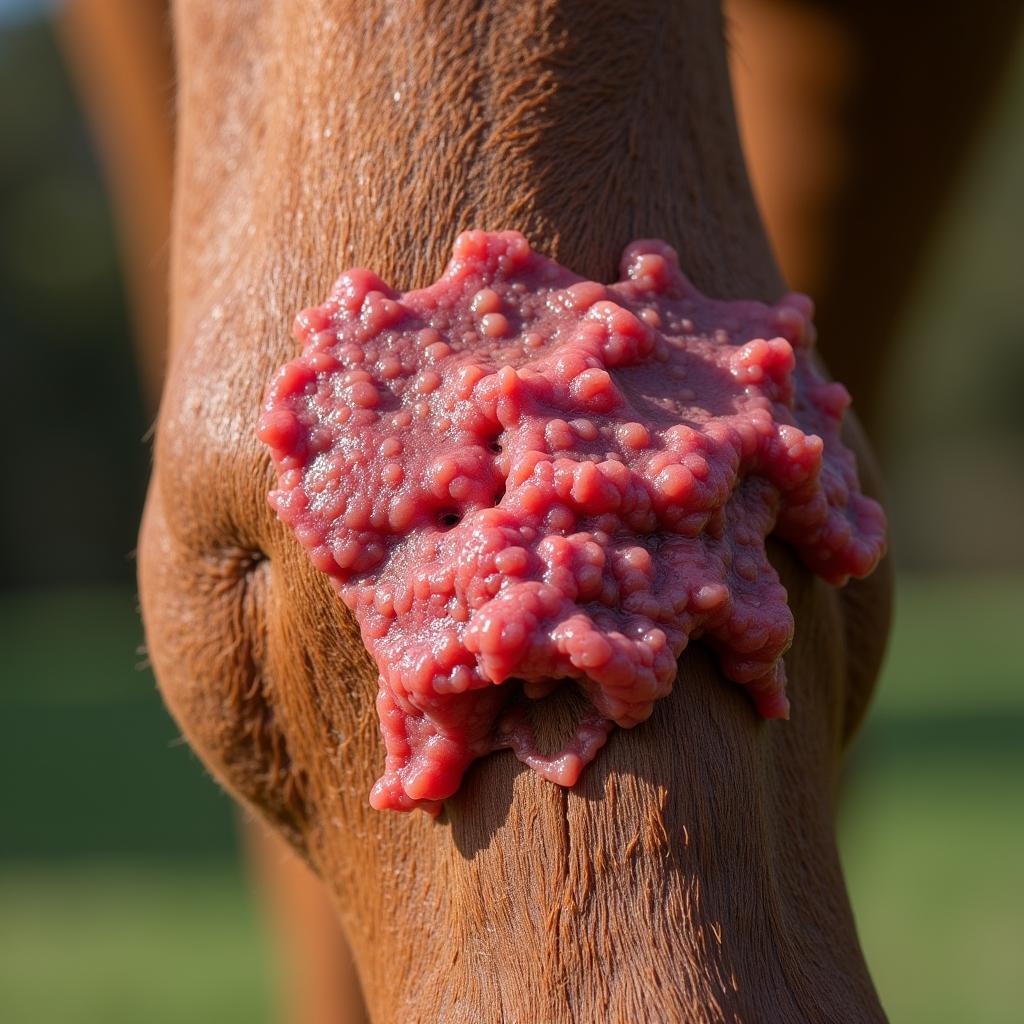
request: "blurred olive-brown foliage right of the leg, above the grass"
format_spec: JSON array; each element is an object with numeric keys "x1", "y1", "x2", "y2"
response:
[{"x1": 881, "y1": 32, "x2": 1024, "y2": 572}]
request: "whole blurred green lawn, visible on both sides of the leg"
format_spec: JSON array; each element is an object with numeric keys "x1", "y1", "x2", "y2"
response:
[{"x1": 0, "y1": 578, "x2": 1024, "y2": 1024}]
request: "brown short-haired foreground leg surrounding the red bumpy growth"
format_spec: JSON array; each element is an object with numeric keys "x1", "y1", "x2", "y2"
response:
[{"x1": 139, "y1": 0, "x2": 889, "y2": 1022}]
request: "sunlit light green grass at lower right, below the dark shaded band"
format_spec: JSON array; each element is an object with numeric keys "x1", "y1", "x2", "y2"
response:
[{"x1": 841, "y1": 752, "x2": 1024, "y2": 1024}]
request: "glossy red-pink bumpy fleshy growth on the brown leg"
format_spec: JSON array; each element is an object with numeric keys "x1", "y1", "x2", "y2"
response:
[{"x1": 259, "y1": 231, "x2": 885, "y2": 810}]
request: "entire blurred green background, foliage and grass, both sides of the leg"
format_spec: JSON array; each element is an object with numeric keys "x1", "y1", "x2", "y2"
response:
[{"x1": 0, "y1": 0, "x2": 1024, "y2": 1024}]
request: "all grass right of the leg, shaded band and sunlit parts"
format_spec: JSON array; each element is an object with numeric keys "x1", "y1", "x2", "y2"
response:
[{"x1": 840, "y1": 577, "x2": 1024, "y2": 1024}]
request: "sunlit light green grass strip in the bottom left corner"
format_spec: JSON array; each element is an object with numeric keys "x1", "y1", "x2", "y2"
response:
[{"x1": 0, "y1": 862, "x2": 273, "y2": 1024}]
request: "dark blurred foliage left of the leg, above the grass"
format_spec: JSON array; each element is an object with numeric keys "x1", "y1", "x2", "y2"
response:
[{"x1": 0, "y1": 20, "x2": 148, "y2": 587}]
